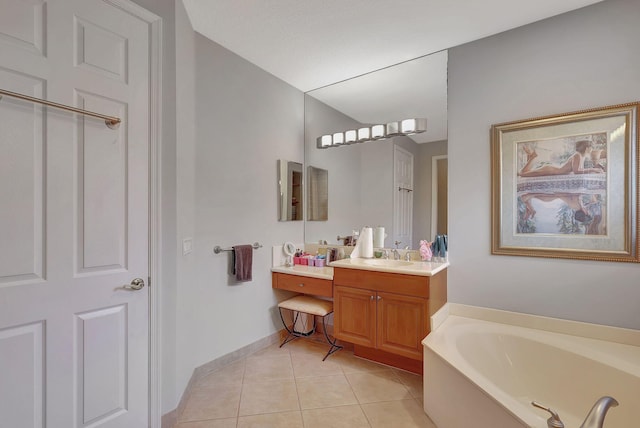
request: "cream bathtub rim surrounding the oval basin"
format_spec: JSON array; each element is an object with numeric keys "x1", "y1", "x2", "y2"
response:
[{"x1": 422, "y1": 304, "x2": 640, "y2": 427}]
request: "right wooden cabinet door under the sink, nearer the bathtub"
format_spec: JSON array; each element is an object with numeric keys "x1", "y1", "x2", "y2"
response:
[{"x1": 376, "y1": 292, "x2": 429, "y2": 360}]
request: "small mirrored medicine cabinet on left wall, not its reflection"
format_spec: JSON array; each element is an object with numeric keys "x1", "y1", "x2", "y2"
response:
[{"x1": 278, "y1": 159, "x2": 304, "y2": 221}]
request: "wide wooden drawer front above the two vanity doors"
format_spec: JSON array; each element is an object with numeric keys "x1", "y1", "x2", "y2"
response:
[{"x1": 333, "y1": 268, "x2": 430, "y2": 298}]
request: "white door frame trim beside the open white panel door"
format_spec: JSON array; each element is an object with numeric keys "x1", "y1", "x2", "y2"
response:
[{"x1": 103, "y1": 0, "x2": 162, "y2": 428}]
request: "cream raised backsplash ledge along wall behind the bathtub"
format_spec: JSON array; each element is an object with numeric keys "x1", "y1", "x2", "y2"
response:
[{"x1": 431, "y1": 302, "x2": 640, "y2": 347}]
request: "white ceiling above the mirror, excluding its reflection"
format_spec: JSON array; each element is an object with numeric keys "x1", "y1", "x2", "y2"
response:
[{"x1": 183, "y1": 0, "x2": 601, "y2": 92}]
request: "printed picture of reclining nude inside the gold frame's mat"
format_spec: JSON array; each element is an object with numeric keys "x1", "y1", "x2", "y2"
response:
[{"x1": 514, "y1": 132, "x2": 608, "y2": 235}]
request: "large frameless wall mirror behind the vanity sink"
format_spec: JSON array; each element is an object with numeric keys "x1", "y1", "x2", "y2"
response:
[{"x1": 305, "y1": 51, "x2": 447, "y2": 249}]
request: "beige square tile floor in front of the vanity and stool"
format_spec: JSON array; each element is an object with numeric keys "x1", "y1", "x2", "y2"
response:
[{"x1": 176, "y1": 340, "x2": 436, "y2": 428}]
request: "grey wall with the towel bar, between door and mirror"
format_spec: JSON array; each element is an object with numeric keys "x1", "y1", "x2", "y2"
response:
[{"x1": 176, "y1": 28, "x2": 304, "y2": 393}]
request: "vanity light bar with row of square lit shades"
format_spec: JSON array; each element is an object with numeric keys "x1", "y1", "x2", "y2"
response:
[{"x1": 316, "y1": 118, "x2": 427, "y2": 149}]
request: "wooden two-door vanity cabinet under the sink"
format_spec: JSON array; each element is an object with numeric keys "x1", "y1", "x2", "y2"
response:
[{"x1": 333, "y1": 268, "x2": 447, "y2": 371}]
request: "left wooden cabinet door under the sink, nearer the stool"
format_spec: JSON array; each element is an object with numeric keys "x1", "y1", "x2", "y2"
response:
[{"x1": 333, "y1": 286, "x2": 376, "y2": 348}]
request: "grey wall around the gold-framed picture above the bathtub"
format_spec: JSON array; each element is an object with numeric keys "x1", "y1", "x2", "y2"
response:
[{"x1": 448, "y1": 0, "x2": 640, "y2": 329}]
